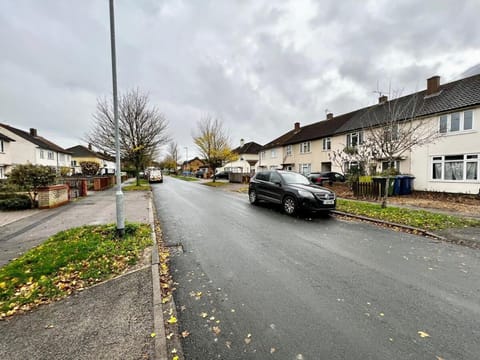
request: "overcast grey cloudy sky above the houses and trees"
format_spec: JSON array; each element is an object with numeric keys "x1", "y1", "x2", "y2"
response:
[{"x1": 0, "y1": 0, "x2": 480, "y2": 157}]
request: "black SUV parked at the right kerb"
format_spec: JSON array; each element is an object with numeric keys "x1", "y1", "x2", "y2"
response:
[{"x1": 248, "y1": 170, "x2": 336, "y2": 215}]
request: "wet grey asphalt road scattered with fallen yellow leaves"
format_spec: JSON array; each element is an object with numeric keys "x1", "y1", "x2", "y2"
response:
[{"x1": 153, "y1": 177, "x2": 480, "y2": 360}]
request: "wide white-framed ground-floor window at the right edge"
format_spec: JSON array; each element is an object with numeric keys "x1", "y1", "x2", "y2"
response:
[{"x1": 432, "y1": 154, "x2": 480, "y2": 181}]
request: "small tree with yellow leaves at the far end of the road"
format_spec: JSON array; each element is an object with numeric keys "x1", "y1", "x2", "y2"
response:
[{"x1": 193, "y1": 116, "x2": 236, "y2": 181}]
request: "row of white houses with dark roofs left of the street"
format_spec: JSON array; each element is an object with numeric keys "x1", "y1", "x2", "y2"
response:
[{"x1": 0, "y1": 123, "x2": 115, "y2": 179}]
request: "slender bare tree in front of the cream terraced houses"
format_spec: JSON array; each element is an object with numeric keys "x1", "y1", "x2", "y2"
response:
[{"x1": 363, "y1": 94, "x2": 440, "y2": 207}]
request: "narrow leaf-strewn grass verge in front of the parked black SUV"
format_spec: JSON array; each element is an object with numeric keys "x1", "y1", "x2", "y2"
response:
[{"x1": 337, "y1": 199, "x2": 480, "y2": 231}]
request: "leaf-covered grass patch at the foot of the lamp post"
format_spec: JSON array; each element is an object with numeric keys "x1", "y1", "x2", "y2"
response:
[{"x1": 0, "y1": 224, "x2": 152, "y2": 319}]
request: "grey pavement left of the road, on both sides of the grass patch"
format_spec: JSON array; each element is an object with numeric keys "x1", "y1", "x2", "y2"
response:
[{"x1": 0, "y1": 184, "x2": 167, "y2": 359}]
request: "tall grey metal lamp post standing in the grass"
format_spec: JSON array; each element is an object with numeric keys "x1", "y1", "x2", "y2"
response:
[{"x1": 110, "y1": 0, "x2": 125, "y2": 237}]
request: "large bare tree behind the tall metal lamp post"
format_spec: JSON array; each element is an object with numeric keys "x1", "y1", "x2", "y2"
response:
[{"x1": 86, "y1": 89, "x2": 169, "y2": 185}]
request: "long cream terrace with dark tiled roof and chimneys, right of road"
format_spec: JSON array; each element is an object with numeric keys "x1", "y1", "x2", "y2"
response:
[{"x1": 258, "y1": 75, "x2": 480, "y2": 194}]
